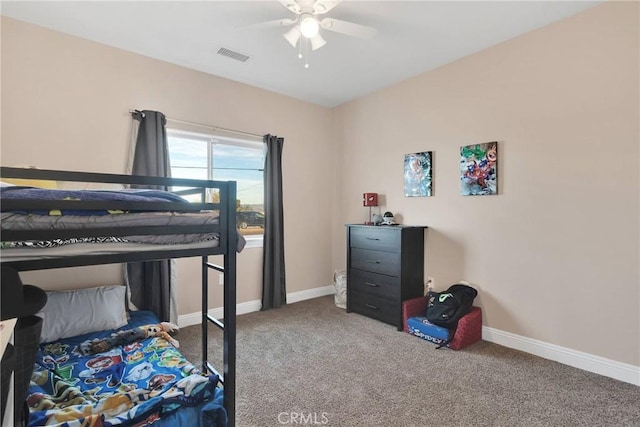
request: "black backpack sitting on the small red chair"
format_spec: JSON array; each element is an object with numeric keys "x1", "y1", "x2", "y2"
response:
[{"x1": 427, "y1": 283, "x2": 478, "y2": 348}]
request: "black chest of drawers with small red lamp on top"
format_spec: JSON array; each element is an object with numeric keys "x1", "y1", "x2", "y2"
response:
[{"x1": 347, "y1": 224, "x2": 427, "y2": 331}]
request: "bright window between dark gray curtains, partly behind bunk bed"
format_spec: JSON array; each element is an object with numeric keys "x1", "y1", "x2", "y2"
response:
[{"x1": 167, "y1": 129, "x2": 265, "y2": 246}]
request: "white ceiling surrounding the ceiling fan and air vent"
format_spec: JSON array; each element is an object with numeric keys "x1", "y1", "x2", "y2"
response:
[{"x1": 1, "y1": 0, "x2": 602, "y2": 107}]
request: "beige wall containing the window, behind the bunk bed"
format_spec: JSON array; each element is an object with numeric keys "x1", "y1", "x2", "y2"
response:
[{"x1": 0, "y1": 17, "x2": 335, "y2": 314}]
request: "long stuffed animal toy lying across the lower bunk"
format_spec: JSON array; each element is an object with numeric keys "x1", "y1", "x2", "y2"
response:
[{"x1": 80, "y1": 322, "x2": 180, "y2": 356}]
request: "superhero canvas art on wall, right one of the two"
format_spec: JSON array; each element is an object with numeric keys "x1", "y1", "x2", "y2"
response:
[{"x1": 460, "y1": 141, "x2": 498, "y2": 196}]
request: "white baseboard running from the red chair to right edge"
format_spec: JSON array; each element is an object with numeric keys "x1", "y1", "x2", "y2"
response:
[{"x1": 482, "y1": 326, "x2": 640, "y2": 386}]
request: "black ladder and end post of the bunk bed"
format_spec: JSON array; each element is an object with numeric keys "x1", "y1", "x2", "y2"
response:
[{"x1": 202, "y1": 181, "x2": 238, "y2": 427}]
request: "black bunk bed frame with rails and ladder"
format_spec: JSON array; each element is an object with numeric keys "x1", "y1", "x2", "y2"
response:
[{"x1": 0, "y1": 167, "x2": 238, "y2": 427}]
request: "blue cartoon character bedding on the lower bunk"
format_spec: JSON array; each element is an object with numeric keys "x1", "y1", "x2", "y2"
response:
[{"x1": 27, "y1": 311, "x2": 227, "y2": 427}]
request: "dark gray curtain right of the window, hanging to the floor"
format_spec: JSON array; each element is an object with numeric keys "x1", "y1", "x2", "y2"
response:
[{"x1": 262, "y1": 135, "x2": 287, "y2": 310}]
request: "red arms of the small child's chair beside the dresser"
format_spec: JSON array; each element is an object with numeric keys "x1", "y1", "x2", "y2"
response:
[{"x1": 402, "y1": 297, "x2": 482, "y2": 350}]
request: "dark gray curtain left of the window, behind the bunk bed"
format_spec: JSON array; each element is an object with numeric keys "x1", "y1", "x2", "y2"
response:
[{"x1": 126, "y1": 110, "x2": 174, "y2": 322}]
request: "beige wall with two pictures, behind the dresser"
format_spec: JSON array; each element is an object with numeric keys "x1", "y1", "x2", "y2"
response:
[{"x1": 333, "y1": 2, "x2": 640, "y2": 366}]
